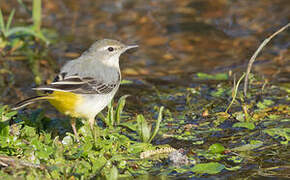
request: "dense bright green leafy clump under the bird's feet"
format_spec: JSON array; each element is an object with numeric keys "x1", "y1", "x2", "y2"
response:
[{"x1": 0, "y1": 98, "x2": 168, "y2": 179}]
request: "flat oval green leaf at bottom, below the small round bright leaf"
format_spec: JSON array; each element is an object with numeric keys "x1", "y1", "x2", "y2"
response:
[{"x1": 191, "y1": 162, "x2": 225, "y2": 174}]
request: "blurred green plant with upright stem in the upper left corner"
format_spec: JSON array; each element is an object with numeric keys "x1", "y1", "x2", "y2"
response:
[{"x1": 0, "y1": 0, "x2": 55, "y2": 84}]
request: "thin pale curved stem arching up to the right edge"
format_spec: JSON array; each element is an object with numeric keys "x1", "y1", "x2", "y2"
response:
[{"x1": 244, "y1": 23, "x2": 290, "y2": 97}]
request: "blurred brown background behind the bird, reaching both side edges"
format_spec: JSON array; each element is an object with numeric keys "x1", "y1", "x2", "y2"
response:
[{"x1": 0, "y1": 0, "x2": 290, "y2": 106}]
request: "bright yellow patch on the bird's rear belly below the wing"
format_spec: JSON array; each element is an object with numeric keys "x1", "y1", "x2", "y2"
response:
[{"x1": 48, "y1": 91, "x2": 81, "y2": 117}]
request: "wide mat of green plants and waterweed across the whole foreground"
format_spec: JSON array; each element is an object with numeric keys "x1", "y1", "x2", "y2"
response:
[{"x1": 0, "y1": 72, "x2": 290, "y2": 179}]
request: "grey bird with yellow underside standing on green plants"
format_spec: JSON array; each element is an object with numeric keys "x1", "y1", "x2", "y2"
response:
[{"x1": 12, "y1": 39, "x2": 138, "y2": 137}]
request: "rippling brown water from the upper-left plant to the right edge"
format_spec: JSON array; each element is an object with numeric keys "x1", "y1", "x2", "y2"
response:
[{"x1": 44, "y1": 0, "x2": 290, "y2": 79}]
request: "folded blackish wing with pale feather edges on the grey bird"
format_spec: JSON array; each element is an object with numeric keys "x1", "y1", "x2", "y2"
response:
[{"x1": 34, "y1": 73, "x2": 120, "y2": 94}]
